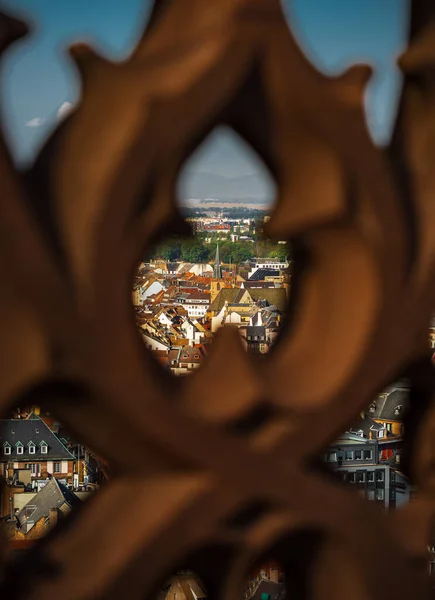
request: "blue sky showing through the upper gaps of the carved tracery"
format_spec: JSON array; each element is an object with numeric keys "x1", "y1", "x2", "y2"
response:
[{"x1": 0, "y1": 0, "x2": 407, "y2": 176}]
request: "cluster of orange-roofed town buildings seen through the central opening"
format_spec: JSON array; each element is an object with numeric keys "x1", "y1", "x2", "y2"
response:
[{"x1": 133, "y1": 246, "x2": 289, "y2": 375}]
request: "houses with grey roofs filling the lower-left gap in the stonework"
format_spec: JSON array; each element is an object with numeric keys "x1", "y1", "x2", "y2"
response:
[{"x1": 0, "y1": 407, "x2": 107, "y2": 550}]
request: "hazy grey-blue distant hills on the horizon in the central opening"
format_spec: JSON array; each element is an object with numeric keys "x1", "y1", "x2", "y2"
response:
[{"x1": 178, "y1": 171, "x2": 275, "y2": 204}]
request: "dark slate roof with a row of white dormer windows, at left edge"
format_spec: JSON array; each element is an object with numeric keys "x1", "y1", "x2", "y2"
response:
[{"x1": 0, "y1": 417, "x2": 75, "y2": 462}]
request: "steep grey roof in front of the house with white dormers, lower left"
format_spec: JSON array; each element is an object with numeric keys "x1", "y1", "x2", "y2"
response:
[{"x1": 17, "y1": 477, "x2": 81, "y2": 533}]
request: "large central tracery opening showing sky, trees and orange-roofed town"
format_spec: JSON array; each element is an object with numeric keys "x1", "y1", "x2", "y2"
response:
[{"x1": 133, "y1": 128, "x2": 291, "y2": 375}]
